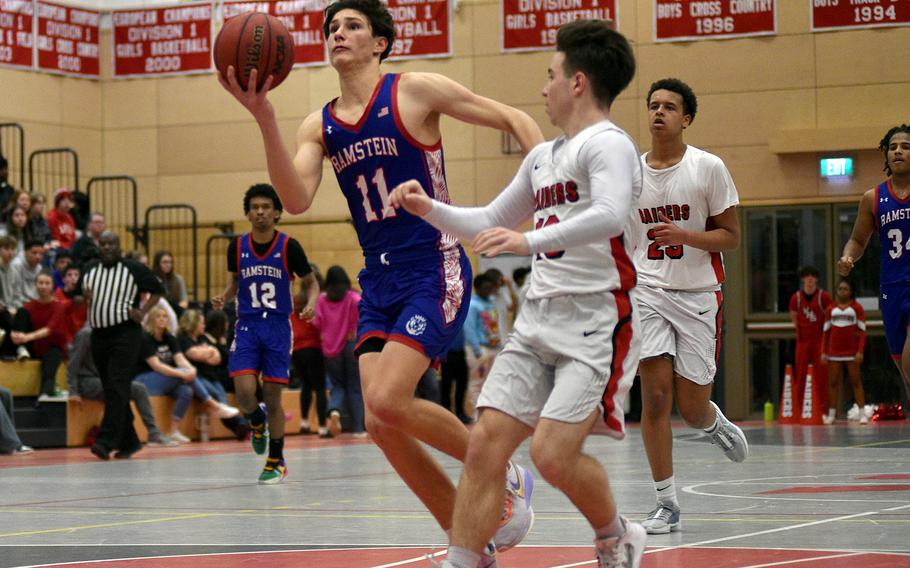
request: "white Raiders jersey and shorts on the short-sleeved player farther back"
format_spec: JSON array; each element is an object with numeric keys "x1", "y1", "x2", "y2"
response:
[{"x1": 632, "y1": 145, "x2": 739, "y2": 385}]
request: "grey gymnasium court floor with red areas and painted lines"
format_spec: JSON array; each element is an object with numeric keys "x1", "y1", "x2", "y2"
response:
[{"x1": 0, "y1": 422, "x2": 910, "y2": 568}]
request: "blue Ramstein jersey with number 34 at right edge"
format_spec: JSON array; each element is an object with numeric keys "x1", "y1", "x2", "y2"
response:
[{"x1": 874, "y1": 178, "x2": 910, "y2": 284}]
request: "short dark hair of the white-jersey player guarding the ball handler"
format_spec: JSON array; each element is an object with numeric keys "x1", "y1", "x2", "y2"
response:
[{"x1": 556, "y1": 20, "x2": 635, "y2": 108}]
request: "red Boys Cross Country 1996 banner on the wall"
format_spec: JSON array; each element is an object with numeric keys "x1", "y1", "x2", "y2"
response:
[{"x1": 654, "y1": 0, "x2": 776, "y2": 42}]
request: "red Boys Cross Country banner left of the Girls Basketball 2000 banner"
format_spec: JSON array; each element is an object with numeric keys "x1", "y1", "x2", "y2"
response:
[{"x1": 37, "y1": 1, "x2": 101, "y2": 78}]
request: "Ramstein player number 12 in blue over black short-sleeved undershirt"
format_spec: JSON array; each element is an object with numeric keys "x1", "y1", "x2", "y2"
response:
[{"x1": 212, "y1": 183, "x2": 319, "y2": 485}]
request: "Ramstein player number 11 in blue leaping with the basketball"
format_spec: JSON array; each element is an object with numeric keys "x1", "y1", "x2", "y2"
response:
[{"x1": 219, "y1": 0, "x2": 543, "y2": 563}]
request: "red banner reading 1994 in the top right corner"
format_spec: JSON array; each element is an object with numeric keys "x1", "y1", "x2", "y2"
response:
[{"x1": 809, "y1": 0, "x2": 910, "y2": 32}]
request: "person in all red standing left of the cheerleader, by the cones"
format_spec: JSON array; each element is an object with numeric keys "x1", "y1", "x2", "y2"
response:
[{"x1": 790, "y1": 266, "x2": 831, "y2": 408}]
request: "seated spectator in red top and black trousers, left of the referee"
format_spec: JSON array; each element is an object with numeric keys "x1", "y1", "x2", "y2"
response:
[{"x1": 9, "y1": 271, "x2": 69, "y2": 402}]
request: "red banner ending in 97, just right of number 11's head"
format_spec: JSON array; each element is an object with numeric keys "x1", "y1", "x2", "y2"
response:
[{"x1": 386, "y1": 0, "x2": 452, "y2": 60}]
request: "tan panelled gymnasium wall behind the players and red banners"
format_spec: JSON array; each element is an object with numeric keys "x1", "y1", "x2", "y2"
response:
[{"x1": 0, "y1": 0, "x2": 910, "y2": 276}]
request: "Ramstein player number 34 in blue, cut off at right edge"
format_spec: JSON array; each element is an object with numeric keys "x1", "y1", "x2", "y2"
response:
[{"x1": 837, "y1": 124, "x2": 910, "y2": 404}]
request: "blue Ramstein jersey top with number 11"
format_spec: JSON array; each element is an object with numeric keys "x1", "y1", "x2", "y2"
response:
[{"x1": 322, "y1": 74, "x2": 455, "y2": 257}]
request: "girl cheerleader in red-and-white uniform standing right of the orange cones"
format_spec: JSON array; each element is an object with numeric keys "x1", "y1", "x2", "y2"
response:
[{"x1": 822, "y1": 278, "x2": 869, "y2": 424}]
